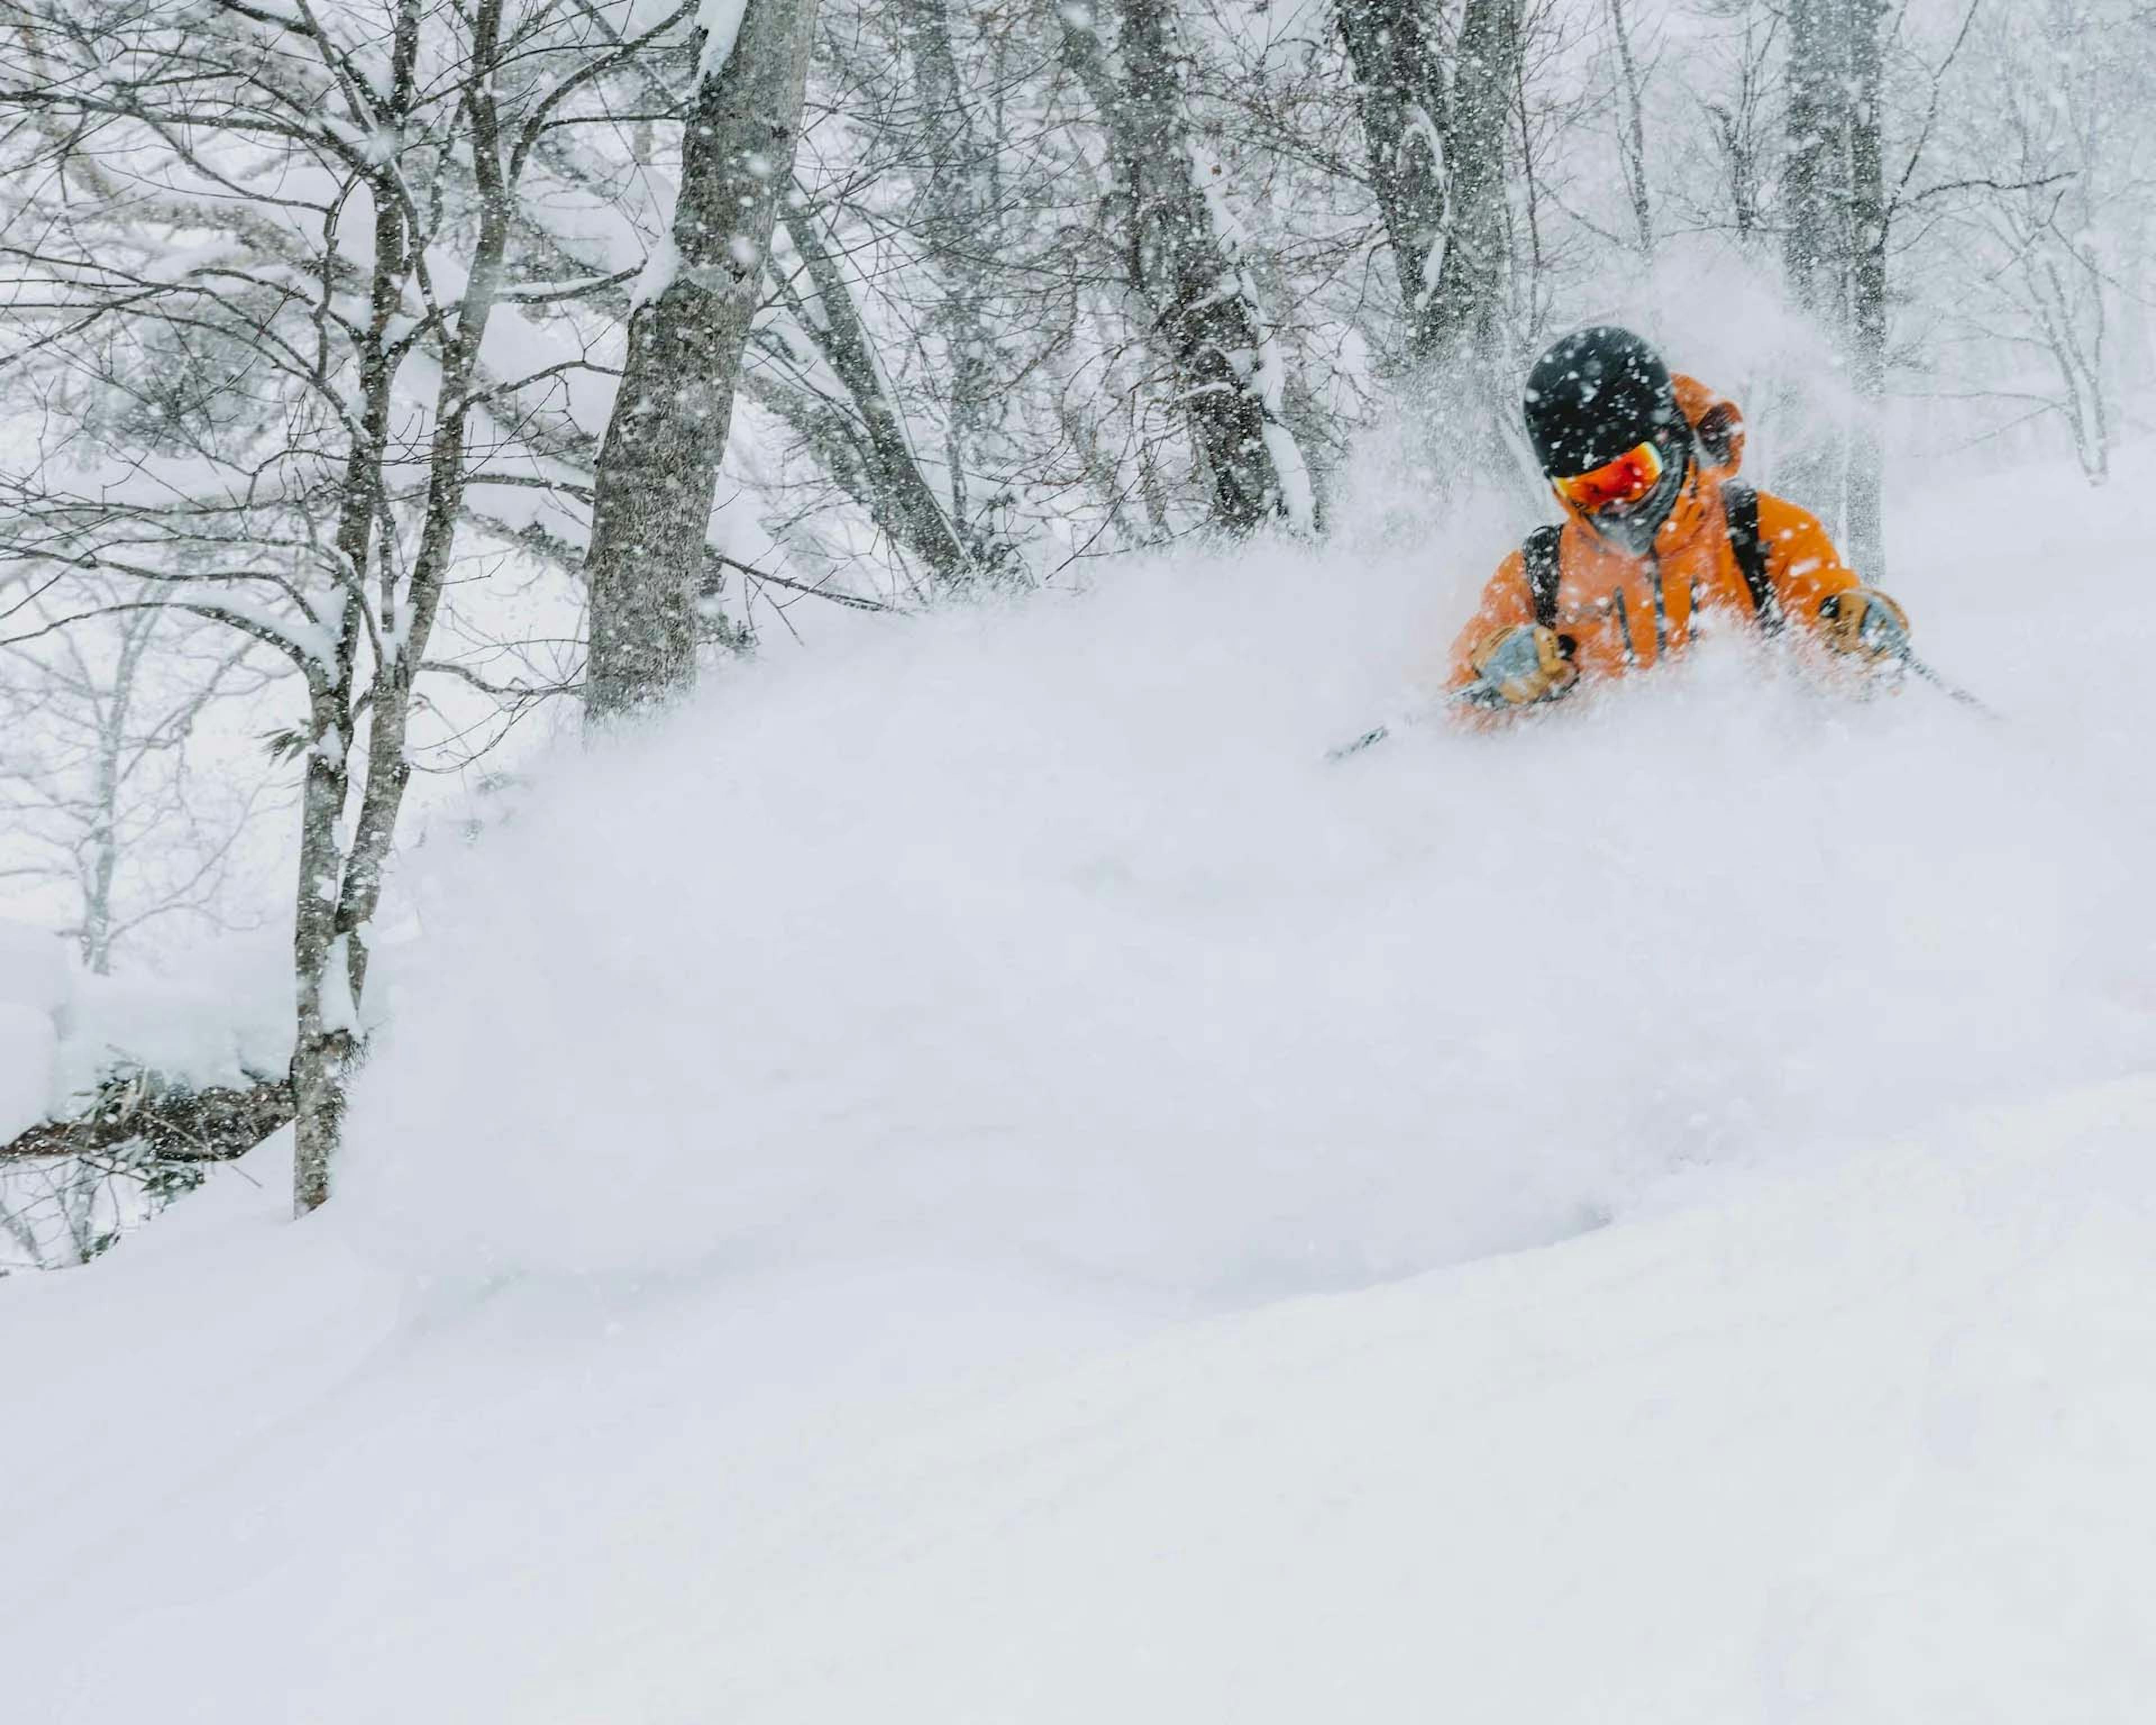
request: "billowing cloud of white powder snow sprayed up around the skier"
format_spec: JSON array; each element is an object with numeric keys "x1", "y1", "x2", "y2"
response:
[{"x1": 345, "y1": 437, "x2": 2156, "y2": 1302}]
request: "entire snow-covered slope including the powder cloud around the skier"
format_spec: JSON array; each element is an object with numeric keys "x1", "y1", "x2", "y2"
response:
[{"x1": 0, "y1": 442, "x2": 2156, "y2": 1725}]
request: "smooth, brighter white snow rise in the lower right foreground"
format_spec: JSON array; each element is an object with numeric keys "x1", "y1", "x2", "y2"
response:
[{"x1": 664, "y1": 1080, "x2": 2156, "y2": 1725}]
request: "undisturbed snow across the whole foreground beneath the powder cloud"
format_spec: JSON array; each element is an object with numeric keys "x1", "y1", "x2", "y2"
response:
[{"x1": 0, "y1": 1078, "x2": 2156, "y2": 1725}]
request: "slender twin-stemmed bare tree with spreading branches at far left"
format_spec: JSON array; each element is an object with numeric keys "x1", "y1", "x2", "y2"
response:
[{"x1": 0, "y1": 0, "x2": 688, "y2": 1210}]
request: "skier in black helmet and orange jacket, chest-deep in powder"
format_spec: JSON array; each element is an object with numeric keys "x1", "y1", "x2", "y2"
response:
[{"x1": 1447, "y1": 323, "x2": 1908, "y2": 711}]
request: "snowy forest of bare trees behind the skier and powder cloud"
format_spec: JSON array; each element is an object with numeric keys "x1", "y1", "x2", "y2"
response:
[{"x1": 0, "y1": 0, "x2": 2156, "y2": 1261}]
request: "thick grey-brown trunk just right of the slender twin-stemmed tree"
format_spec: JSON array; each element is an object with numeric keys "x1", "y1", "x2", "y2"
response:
[{"x1": 584, "y1": 0, "x2": 815, "y2": 720}]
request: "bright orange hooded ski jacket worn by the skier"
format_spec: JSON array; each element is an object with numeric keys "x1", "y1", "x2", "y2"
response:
[{"x1": 1447, "y1": 375, "x2": 1856, "y2": 688}]
